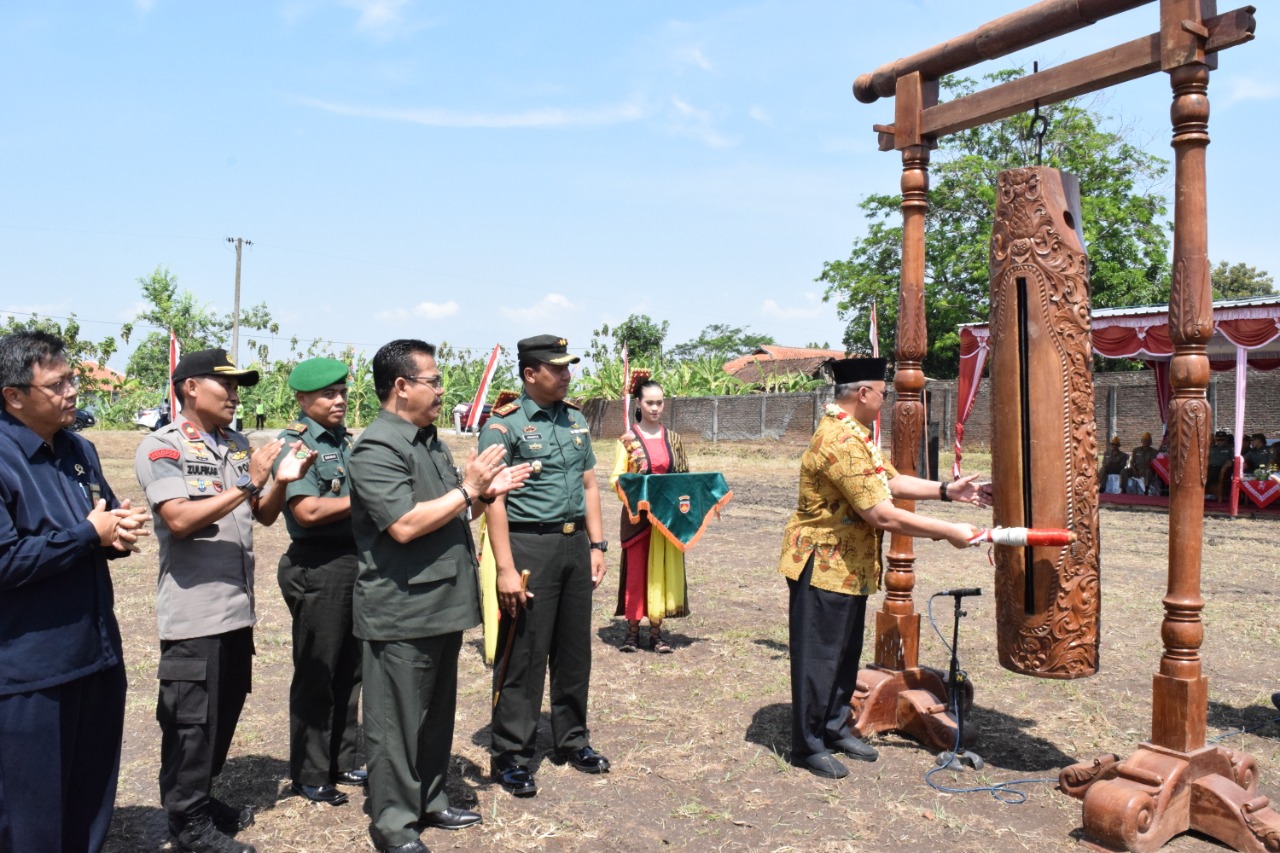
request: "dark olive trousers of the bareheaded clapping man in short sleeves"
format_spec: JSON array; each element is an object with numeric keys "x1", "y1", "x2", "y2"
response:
[{"x1": 361, "y1": 631, "x2": 462, "y2": 848}]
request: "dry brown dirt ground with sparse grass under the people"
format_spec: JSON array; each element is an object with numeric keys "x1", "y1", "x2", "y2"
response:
[{"x1": 86, "y1": 430, "x2": 1280, "y2": 853}]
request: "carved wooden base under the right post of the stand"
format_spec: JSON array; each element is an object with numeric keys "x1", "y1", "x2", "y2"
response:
[{"x1": 1059, "y1": 743, "x2": 1280, "y2": 853}]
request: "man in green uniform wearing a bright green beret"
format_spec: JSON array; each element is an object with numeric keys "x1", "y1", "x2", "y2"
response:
[{"x1": 272, "y1": 359, "x2": 367, "y2": 806}]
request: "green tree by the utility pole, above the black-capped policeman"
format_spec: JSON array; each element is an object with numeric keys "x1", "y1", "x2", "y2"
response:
[{"x1": 120, "y1": 265, "x2": 279, "y2": 388}]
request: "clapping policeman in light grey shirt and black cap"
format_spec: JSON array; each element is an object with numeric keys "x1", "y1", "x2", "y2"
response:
[{"x1": 133, "y1": 350, "x2": 314, "y2": 853}]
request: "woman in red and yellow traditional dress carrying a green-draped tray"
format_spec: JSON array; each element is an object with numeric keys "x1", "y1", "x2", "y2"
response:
[{"x1": 609, "y1": 374, "x2": 689, "y2": 654}]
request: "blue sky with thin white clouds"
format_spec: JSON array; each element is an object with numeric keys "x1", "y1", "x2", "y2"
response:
[{"x1": 0, "y1": 0, "x2": 1280, "y2": 369}]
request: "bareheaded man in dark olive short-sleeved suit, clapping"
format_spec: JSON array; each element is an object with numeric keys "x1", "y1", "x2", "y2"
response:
[{"x1": 351, "y1": 339, "x2": 529, "y2": 853}]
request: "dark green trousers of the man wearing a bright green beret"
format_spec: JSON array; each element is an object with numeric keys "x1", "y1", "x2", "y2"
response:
[{"x1": 276, "y1": 539, "x2": 361, "y2": 785}]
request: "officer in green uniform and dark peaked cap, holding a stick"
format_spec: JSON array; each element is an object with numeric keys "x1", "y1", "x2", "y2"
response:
[{"x1": 480, "y1": 334, "x2": 609, "y2": 797}]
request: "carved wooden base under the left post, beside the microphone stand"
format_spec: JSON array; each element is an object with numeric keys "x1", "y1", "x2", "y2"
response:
[{"x1": 850, "y1": 663, "x2": 977, "y2": 751}]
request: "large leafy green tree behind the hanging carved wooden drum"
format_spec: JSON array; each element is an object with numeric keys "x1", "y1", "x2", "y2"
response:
[{"x1": 817, "y1": 69, "x2": 1169, "y2": 378}]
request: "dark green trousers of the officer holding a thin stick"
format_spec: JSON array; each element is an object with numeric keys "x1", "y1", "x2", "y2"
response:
[{"x1": 490, "y1": 530, "x2": 593, "y2": 767}]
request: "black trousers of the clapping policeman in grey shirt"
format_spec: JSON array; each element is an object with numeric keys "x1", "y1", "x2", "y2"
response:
[{"x1": 156, "y1": 628, "x2": 253, "y2": 831}]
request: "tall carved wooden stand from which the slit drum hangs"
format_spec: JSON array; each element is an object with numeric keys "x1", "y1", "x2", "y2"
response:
[{"x1": 852, "y1": 0, "x2": 1280, "y2": 852}]
